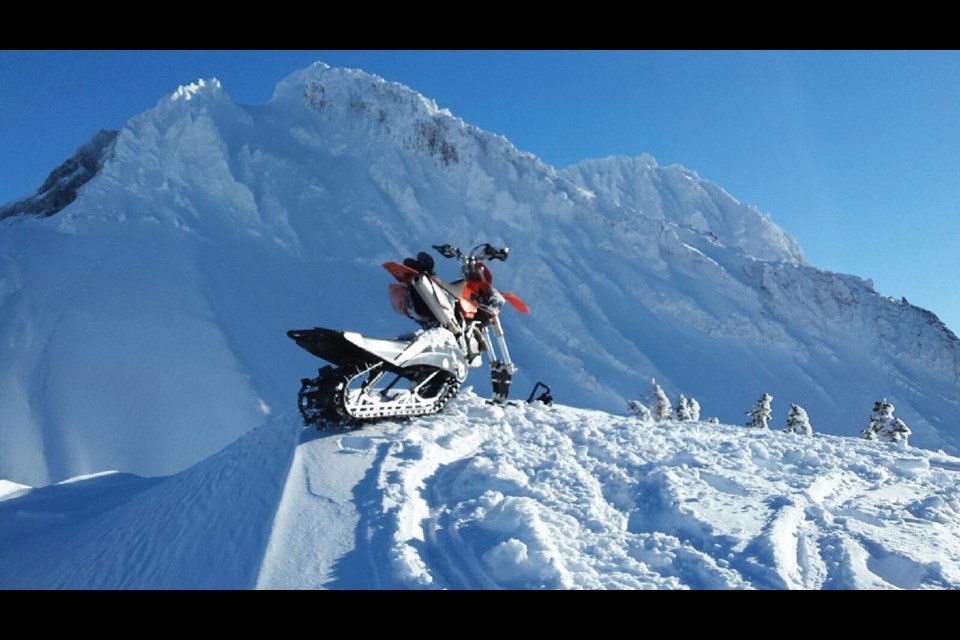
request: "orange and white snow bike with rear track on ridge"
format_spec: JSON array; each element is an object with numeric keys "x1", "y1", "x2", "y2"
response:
[{"x1": 287, "y1": 244, "x2": 529, "y2": 428}]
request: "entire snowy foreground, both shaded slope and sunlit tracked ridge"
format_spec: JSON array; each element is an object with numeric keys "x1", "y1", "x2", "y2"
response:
[{"x1": 0, "y1": 390, "x2": 960, "y2": 589}]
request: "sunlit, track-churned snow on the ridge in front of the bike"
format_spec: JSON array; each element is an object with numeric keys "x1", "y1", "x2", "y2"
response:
[{"x1": 258, "y1": 392, "x2": 960, "y2": 589}]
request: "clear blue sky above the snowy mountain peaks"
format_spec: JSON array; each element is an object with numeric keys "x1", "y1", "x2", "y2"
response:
[{"x1": 0, "y1": 51, "x2": 960, "y2": 332}]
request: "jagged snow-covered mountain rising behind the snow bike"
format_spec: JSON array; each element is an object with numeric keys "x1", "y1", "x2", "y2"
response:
[{"x1": 0, "y1": 64, "x2": 960, "y2": 485}]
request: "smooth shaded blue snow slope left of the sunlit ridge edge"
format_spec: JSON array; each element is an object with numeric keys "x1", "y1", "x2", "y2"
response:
[{"x1": 0, "y1": 417, "x2": 301, "y2": 589}]
